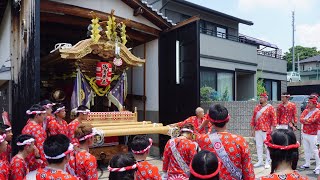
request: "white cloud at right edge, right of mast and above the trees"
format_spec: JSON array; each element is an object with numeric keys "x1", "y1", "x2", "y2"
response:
[{"x1": 296, "y1": 23, "x2": 320, "y2": 50}]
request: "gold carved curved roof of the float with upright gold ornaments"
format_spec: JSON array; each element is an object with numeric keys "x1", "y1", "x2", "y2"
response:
[{"x1": 59, "y1": 10, "x2": 145, "y2": 66}]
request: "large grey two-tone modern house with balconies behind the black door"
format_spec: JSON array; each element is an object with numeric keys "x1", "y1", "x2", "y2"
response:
[{"x1": 148, "y1": 0, "x2": 287, "y2": 101}]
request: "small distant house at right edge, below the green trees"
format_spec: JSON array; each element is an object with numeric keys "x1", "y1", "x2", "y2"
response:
[{"x1": 299, "y1": 55, "x2": 320, "y2": 81}]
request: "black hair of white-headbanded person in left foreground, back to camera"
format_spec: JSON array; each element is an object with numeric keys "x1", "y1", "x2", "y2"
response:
[{"x1": 43, "y1": 134, "x2": 70, "y2": 164}]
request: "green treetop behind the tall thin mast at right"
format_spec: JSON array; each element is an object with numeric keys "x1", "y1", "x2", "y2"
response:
[{"x1": 283, "y1": 46, "x2": 320, "y2": 71}]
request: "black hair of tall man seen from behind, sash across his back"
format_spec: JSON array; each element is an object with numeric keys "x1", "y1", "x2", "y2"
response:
[{"x1": 209, "y1": 104, "x2": 229, "y2": 128}]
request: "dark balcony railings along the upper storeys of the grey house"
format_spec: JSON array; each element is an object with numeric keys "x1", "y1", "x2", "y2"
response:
[{"x1": 200, "y1": 27, "x2": 283, "y2": 59}]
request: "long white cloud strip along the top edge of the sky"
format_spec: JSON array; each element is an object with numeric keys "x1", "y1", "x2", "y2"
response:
[{"x1": 238, "y1": 0, "x2": 316, "y2": 11}]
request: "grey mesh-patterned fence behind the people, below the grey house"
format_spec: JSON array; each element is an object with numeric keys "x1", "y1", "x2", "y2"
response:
[{"x1": 201, "y1": 101, "x2": 301, "y2": 140}]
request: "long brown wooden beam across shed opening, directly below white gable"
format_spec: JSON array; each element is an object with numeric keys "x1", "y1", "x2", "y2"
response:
[{"x1": 41, "y1": 1, "x2": 160, "y2": 37}]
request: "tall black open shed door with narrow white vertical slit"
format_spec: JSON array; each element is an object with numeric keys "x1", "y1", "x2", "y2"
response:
[{"x1": 159, "y1": 21, "x2": 200, "y2": 154}]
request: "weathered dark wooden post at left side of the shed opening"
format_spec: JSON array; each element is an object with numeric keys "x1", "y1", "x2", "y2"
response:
[{"x1": 10, "y1": 0, "x2": 40, "y2": 152}]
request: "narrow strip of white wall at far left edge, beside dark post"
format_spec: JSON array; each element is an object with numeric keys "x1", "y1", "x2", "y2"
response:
[{"x1": 0, "y1": 3, "x2": 11, "y2": 80}]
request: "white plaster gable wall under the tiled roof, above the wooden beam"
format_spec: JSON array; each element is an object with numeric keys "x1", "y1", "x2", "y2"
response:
[{"x1": 51, "y1": 0, "x2": 159, "y2": 29}]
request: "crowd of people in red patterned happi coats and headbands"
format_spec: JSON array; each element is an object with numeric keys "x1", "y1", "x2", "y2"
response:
[{"x1": 0, "y1": 93, "x2": 320, "y2": 180}]
